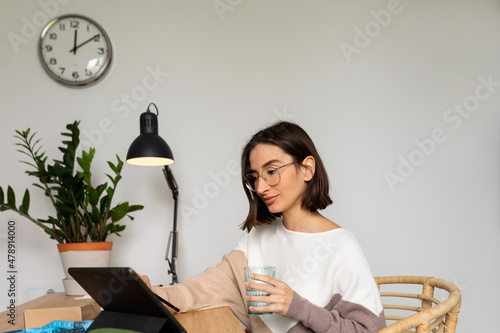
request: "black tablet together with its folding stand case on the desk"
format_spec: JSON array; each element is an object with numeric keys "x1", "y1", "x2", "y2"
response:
[{"x1": 68, "y1": 267, "x2": 186, "y2": 333}]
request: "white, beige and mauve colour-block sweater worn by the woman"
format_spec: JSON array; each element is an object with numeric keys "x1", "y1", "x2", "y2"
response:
[{"x1": 153, "y1": 220, "x2": 385, "y2": 333}]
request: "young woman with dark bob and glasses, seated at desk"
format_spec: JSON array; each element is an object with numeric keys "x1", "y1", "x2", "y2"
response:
[{"x1": 153, "y1": 122, "x2": 385, "y2": 333}]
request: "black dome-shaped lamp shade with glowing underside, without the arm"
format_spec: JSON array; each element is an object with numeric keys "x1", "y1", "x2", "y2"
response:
[{"x1": 127, "y1": 108, "x2": 174, "y2": 166}]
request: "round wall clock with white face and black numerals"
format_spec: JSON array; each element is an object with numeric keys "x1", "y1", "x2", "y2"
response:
[{"x1": 39, "y1": 15, "x2": 112, "y2": 86}]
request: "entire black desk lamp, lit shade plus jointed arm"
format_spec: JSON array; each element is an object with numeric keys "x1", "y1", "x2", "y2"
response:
[{"x1": 127, "y1": 103, "x2": 179, "y2": 284}]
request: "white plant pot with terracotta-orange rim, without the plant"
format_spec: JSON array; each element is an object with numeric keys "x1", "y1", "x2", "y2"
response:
[{"x1": 57, "y1": 242, "x2": 113, "y2": 295}]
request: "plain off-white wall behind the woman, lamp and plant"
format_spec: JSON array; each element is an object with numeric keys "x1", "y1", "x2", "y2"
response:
[{"x1": 0, "y1": 0, "x2": 500, "y2": 332}]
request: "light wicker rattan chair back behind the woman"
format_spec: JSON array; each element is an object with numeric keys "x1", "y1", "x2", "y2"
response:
[{"x1": 375, "y1": 276, "x2": 461, "y2": 333}]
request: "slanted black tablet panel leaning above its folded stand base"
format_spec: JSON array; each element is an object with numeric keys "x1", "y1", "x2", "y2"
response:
[{"x1": 68, "y1": 267, "x2": 185, "y2": 332}]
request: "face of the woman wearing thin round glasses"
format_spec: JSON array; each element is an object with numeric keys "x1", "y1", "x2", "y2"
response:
[{"x1": 249, "y1": 144, "x2": 307, "y2": 214}]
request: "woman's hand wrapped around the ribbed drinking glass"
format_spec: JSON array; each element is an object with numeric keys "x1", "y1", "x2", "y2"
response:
[{"x1": 245, "y1": 274, "x2": 295, "y2": 316}]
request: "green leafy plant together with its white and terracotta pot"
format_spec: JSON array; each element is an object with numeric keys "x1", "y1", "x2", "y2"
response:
[{"x1": 0, "y1": 121, "x2": 143, "y2": 295}]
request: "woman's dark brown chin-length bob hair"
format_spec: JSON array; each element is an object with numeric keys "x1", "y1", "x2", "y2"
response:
[{"x1": 241, "y1": 121, "x2": 333, "y2": 232}]
